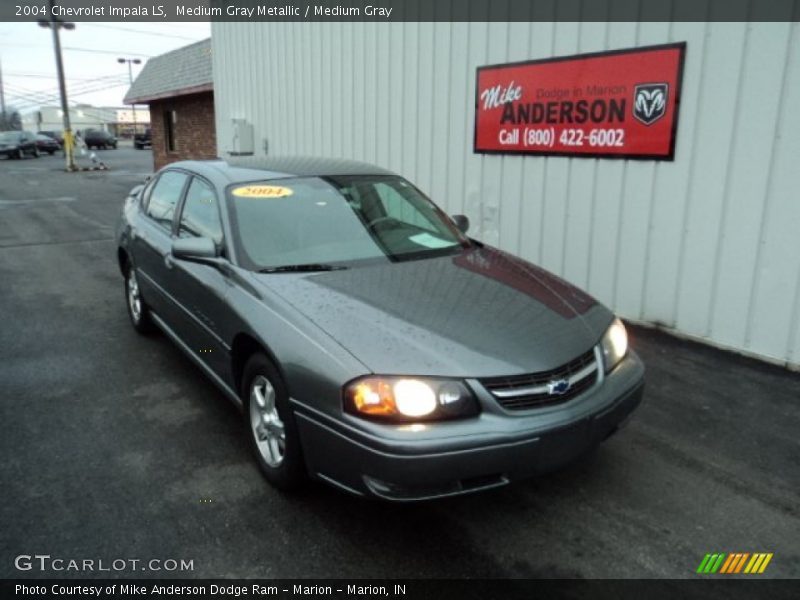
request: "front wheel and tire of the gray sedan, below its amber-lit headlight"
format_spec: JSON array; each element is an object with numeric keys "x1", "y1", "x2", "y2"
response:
[{"x1": 240, "y1": 354, "x2": 307, "y2": 491}]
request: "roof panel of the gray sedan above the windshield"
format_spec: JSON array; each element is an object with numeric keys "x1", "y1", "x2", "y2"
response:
[{"x1": 169, "y1": 156, "x2": 394, "y2": 183}]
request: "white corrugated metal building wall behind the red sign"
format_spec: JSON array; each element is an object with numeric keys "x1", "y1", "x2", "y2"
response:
[{"x1": 212, "y1": 22, "x2": 800, "y2": 366}]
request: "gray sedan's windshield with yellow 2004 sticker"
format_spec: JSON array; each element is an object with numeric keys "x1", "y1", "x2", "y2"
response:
[{"x1": 228, "y1": 176, "x2": 470, "y2": 270}]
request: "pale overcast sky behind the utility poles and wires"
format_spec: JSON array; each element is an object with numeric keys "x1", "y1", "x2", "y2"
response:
[{"x1": 0, "y1": 22, "x2": 211, "y2": 114}]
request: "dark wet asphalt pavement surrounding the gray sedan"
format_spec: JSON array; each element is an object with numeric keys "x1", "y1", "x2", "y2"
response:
[{"x1": 0, "y1": 148, "x2": 800, "y2": 578}]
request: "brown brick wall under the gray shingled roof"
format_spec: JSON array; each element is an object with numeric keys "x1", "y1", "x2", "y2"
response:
[{"x1": 150, "y1": 92, "x2": 217, "y2": 170}]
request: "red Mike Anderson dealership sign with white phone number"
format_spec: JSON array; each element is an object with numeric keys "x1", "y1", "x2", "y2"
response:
[{"x1": 475, "y1": 42, "x2": 686, "y2": 160}]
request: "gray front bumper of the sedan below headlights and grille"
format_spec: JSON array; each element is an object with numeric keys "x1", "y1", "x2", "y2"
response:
[{"x1": 295, "y1": 352, "x2": 644, "y2": 501}]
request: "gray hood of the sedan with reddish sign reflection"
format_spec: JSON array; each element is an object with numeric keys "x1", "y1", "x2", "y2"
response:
[{"x1": 250, "y1": 247, "x2": 613, "y2": 377}]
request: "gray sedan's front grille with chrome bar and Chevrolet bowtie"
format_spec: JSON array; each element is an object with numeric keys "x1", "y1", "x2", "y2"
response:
[{"x1": 480, "y1": 348, "x2": 598, "y2": 410}]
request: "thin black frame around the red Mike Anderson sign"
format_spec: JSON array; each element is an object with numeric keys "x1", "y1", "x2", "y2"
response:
[{"x1": 472, "y1": 42, "x2": 687, "y2": 162}]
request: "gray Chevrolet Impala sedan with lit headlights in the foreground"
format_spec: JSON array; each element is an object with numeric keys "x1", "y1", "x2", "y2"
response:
[{"x1": 117, "y1": 158, "x2": 644, "y2": 501}]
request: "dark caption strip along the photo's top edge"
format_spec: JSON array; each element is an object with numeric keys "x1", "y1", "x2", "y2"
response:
[{"x1": 0, "y1": 0, "x2": 800, "y2": 23}]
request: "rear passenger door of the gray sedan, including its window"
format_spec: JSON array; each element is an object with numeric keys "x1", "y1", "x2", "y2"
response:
[{"x1": 131, "y1": 170, "x2": 189, "y2": 328}]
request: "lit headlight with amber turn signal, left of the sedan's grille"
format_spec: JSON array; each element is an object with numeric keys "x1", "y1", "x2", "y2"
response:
[{"x1": 344, "y1": 377, "x2": 478, "y2": 423}]
